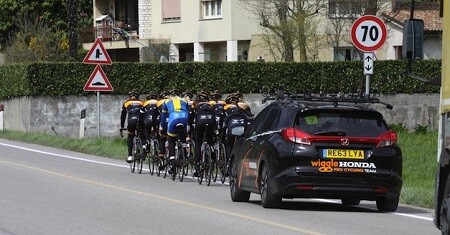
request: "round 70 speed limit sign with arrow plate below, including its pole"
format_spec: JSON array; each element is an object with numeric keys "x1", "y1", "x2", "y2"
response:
[{"x1": 351, "y1": 15, "x2": 387, "y2": 97}]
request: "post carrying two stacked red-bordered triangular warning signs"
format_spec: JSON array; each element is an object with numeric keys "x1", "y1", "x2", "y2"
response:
[{"x1": 83, "y1": 38, "x2": 113, "y2": 137}]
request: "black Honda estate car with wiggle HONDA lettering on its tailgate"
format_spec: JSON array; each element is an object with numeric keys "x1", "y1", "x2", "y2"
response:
[{"x1": 230, "y1": 93, "x2": 402, "y2": 211}]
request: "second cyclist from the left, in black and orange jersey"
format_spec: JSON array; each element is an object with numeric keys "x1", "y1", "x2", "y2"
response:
[{"x1": 144, "y1": 92, "x2": 159, "y2": 145}]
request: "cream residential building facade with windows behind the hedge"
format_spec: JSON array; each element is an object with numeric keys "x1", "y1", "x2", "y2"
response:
[{"x1": 83, "y1": 0, "x2": 442, "y2": 62}]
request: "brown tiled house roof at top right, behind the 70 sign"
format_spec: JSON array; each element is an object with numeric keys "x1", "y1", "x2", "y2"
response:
[{"x1": 382, "y1": 2, "x2": 442, "y2": 32}]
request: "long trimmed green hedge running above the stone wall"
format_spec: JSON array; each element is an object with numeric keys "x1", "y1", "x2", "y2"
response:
[{"x1": 0, "y1": 60, "x2": 441, "y2": 99}]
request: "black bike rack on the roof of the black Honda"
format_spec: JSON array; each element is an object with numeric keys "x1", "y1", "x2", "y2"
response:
[{"x1": 261, "y1": 87, "x2": 393, "y2": 109}]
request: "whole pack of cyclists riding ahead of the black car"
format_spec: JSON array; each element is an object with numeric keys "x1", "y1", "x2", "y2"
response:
[{"x1": 120, "y1": 88, "x2": 253, "y2": 177}]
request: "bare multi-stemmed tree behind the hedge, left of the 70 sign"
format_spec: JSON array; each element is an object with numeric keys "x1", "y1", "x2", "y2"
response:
[{"x1": 239, "y1": 0, "x2": 327, "y2": 62}]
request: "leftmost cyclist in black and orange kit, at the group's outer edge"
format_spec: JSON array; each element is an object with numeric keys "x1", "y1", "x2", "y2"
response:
[{"x1": 120, "y1": 89, "x2": 145, "y2": 163}]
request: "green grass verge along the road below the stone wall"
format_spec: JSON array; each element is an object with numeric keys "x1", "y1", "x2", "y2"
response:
[{"x1": 0, "y1": 130, "x2": 437, "y2": 208}]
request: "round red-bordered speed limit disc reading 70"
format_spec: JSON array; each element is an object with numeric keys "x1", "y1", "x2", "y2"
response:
[{"x1": 351, "y1": 15, "x2": 387, "y2": 52}]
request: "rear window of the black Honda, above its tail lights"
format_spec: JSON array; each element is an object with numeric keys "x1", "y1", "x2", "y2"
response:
[{"x1": 296, "y1": 111, "x2": 389, "y2": 137}]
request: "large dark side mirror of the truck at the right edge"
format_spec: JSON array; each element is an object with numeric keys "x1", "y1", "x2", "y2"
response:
[{"x1": 402, "y1": 19, "x2": 424, "y2": 60}]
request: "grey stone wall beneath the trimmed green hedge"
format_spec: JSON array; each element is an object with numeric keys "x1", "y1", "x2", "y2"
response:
[{"x1": 0, "y1": 93, "x2": 439, "y2": 137}]
